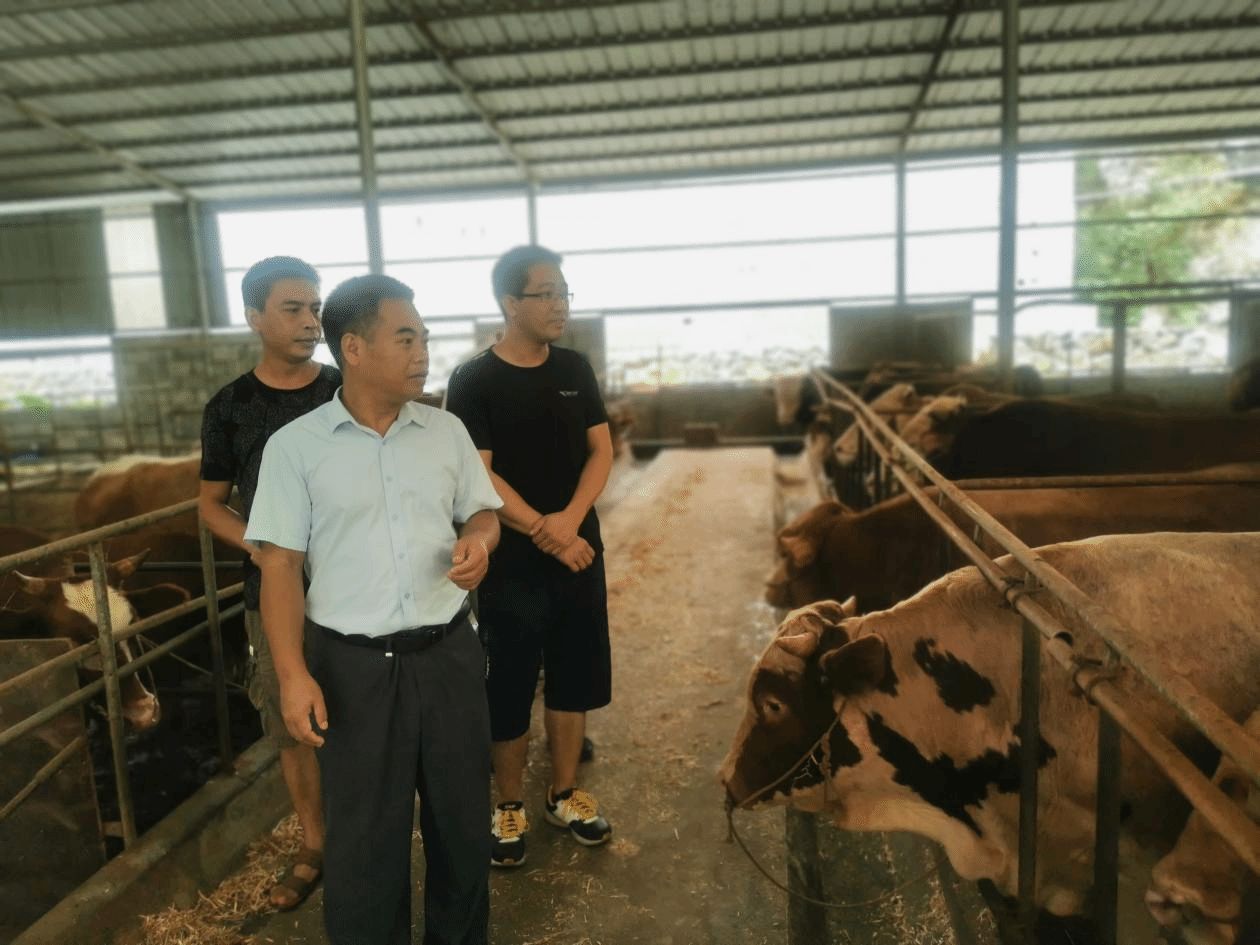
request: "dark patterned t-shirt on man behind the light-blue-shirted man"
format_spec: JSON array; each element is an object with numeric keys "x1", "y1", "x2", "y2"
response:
[{"x1": 202, "y1": 364, "x2": 341, "y2": 610}]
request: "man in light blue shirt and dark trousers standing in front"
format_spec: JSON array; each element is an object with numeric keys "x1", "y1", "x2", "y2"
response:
[{"x1": 244, "y1": 276, "x2": 503, "y2": 945}]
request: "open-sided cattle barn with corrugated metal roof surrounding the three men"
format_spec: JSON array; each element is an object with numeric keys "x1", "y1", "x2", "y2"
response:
[{"x1": 0, "y1": 0, "x2": 1260, "y2": 945}]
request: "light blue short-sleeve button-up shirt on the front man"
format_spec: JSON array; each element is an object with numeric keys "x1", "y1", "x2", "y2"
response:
[{"x1": 244, "y1": 391, "x2": 503, "y2": 636}]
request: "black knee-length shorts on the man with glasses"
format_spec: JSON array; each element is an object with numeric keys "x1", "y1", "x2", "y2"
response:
[{"x1": 476, "y1": 553, "x2": 612, "y2": 742}]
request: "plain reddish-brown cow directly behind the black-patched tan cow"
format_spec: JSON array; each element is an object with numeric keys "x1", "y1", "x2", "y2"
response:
[{"x1": 766, "y1": 476, "x2": 1260, "y2": 610}]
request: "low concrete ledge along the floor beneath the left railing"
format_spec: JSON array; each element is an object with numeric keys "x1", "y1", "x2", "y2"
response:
[{"x1": 11, "y1": 738, "x2": 290, "y2": 945}]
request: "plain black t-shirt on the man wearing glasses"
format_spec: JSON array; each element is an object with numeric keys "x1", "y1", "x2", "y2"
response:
[{"x1": 446, "y1": 345, "x2": 609, "y2": 576}]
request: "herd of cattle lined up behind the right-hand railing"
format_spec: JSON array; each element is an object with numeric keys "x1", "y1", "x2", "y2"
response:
[{"x1": 721, "y1": 357, "x2": 1260, "y2": 944}]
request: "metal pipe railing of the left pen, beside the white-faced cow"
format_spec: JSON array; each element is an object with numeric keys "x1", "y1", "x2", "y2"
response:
[{"x1": 0, "y1": 499, "x2": 244, "y2": 847}]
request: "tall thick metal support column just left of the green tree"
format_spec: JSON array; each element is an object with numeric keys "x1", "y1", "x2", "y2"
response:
[{"x1": 998, "y1": 0, "x2": 1019, "y2": 389}]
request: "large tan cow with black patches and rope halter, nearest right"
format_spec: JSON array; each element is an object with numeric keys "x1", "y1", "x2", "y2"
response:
[{"x1": 719, "y1": 533, "x2": 1260, "y2": 942}]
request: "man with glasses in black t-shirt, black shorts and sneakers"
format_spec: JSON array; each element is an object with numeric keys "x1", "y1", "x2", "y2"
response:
[{"x1": 446, "y1": 246, "x2": 612, "y2": 867}]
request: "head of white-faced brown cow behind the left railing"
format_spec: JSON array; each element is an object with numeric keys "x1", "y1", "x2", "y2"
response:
[{"x1": 0, "y1": 533, "x2": 188, "y2": 731}]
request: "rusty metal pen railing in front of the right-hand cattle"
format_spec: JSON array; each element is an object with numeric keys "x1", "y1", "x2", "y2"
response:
[{"x1": 811, "y1": 370, "x2": 1260, "y2": 945}]
